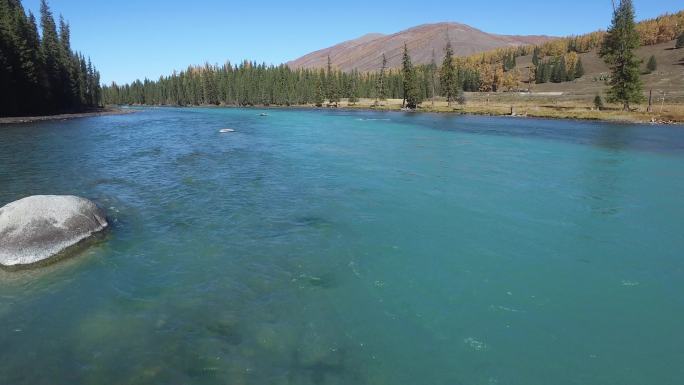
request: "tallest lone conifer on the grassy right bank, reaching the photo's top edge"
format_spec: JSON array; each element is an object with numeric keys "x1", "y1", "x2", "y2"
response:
[{"x1": 599, "y1": 0, "x2": 644, "y2": 111}]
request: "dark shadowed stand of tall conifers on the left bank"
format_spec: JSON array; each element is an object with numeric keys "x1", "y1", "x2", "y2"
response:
[{"x1": 0, "y1": 0, "x2": 101, "y2": 116}]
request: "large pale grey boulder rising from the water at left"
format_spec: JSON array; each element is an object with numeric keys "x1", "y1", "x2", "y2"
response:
[{"x1": 0, "y1": 195, "x2": 107, "y2": 266}]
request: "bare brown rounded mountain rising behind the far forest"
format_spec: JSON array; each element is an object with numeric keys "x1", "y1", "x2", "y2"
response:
[{"x1": 288, "y1": 23, "x2": 553, "y2": 71}]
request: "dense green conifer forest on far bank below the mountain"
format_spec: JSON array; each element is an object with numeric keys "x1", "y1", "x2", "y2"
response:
[{"x1": 103, "y1": 57, "x2": 481, "y2": 106}]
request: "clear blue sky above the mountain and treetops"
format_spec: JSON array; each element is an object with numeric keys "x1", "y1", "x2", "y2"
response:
[{"x1": 23, "y1": 0, "x2": 684, "y2": 83}]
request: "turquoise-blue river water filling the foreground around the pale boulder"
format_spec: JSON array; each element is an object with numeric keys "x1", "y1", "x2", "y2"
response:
[{"x1": 0, "y1": 109, "x2": 684, "y2": 385}]
